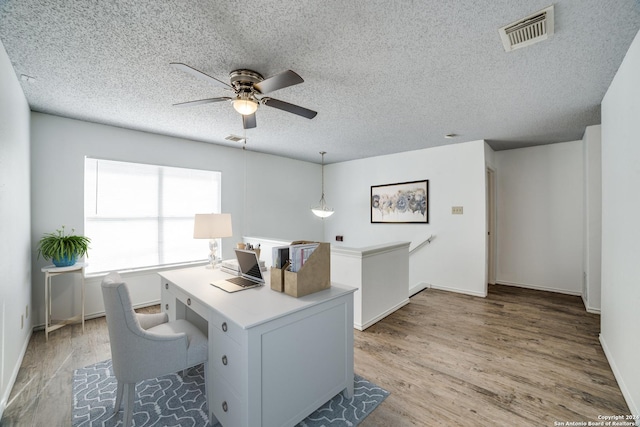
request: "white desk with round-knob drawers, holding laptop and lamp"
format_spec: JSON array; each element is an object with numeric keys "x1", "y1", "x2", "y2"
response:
[{"x1": 160, "y1": 267, "x2": 355, "y2": 427}]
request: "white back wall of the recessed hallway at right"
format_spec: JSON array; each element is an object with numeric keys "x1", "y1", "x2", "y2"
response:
[{"x1": 495, "y1": 141, "x2": 583, "y2": 295}]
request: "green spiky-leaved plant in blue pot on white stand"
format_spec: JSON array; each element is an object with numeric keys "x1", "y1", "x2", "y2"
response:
[{"x1": 38, "y1": 225, "x2": 91, "y2": 267}]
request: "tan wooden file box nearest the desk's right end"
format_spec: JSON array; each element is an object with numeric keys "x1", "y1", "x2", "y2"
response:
[{"x1": 286, "y1": 243, "x2": 331, "y2": 298}]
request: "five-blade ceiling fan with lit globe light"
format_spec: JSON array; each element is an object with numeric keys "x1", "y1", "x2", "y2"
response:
[{"x1": 170, "y1": 62, "x2": 318, "y2": 129}]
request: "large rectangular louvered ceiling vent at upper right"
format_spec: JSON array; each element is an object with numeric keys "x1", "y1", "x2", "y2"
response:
[{"x1": 498, "y1": 5, "x2": 553, "y2": 52}]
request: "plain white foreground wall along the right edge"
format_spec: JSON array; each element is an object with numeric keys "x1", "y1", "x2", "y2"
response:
[{"x1": 600, "y1": 27, "x2": 640, "y2": 415}]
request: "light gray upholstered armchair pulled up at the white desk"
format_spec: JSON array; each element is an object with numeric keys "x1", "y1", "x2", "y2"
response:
[{"x1": 102, "y1": 273, "x2": 209, "y2": 427}]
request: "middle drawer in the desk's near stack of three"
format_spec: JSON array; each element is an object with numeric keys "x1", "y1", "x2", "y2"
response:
[{"x1": 209, "y1": 328, "x2": 242, "y2": 396}]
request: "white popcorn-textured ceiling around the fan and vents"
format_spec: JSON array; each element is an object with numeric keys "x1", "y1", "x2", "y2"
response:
[{"x1": 0, "y1": 0, "x2": 640, "y2": 163}]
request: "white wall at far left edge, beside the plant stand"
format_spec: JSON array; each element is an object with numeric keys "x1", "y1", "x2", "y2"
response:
[{"x1": 0, "y1": 43, "x2": 31, "y2": 418}]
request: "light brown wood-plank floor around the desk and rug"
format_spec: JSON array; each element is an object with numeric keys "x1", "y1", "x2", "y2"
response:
[{"x1": 0, "y1": 286, "x2": 629, "y2": 427}]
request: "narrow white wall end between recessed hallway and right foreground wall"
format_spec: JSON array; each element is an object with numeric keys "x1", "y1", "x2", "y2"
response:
[{"x1": 582, "y1": 125, "x2": 602, "y2": 313}]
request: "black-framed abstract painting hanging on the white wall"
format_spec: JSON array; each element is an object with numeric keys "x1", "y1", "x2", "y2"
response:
[{"x1": 371, "y1": 180, "x2": 429, "y2": 224}]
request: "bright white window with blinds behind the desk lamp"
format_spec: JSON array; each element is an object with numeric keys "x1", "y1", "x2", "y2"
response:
[{"x1": 84, "y1": 158, "x2": 222, "y2": 273}]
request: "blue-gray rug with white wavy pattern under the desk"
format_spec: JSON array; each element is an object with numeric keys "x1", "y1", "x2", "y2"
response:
[{"x1": 72, "y1": 360, "x2": 389, "y2": 427}]
